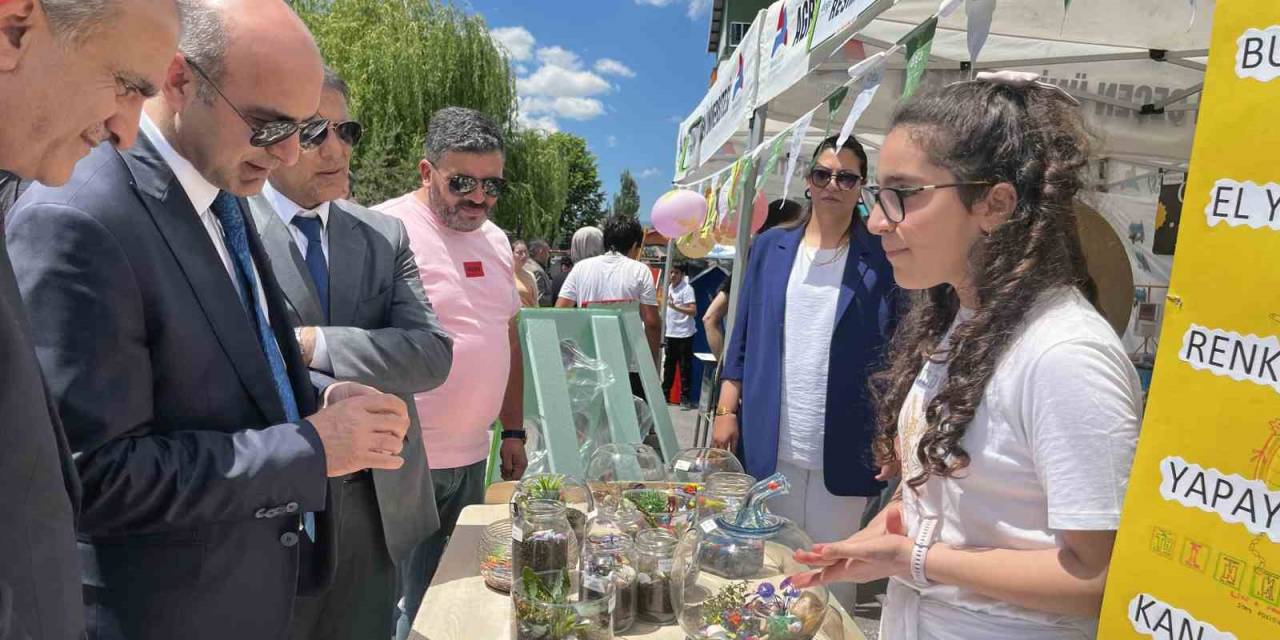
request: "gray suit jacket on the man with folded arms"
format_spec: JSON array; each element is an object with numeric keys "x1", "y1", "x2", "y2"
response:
[{"x1": 248, "y1": 196, "x2": 453, "y2": 563}]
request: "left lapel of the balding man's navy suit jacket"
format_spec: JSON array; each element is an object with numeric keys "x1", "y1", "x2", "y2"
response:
[{"x1": 122, "y1": 136, "x2": 284, "y2": 422}]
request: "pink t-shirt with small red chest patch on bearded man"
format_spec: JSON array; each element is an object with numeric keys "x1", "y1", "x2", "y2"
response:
[{"x1": 374, "y1": 193, "x2": 520, "y2": 468}]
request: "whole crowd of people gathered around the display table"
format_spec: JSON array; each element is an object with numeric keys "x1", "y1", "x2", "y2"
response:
[{"x1": 0, "y1": 0, "x2": 1142, "y2": 640}]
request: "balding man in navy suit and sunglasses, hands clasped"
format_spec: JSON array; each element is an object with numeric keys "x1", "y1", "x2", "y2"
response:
[{"x1": 8, "y1": 0, "x2": 408, "y2": 640}]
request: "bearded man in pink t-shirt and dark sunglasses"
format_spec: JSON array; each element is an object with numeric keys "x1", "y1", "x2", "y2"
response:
[{"x1": 374, "y1": 106, "x2": 527, "y2": 639}]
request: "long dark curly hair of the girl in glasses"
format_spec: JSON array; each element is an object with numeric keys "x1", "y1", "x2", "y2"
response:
[{"x1": 870, "y1": 81, "x2": 1092, "y2": 488}]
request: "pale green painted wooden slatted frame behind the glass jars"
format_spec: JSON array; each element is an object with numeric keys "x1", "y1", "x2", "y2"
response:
[{"x1": 489, "y1": 303, "x2": 680, "y2": 480}]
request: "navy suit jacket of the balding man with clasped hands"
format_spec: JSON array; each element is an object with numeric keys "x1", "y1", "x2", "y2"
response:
[{"x1": 6, "y1": 136, "x2": 334, "y2": 640}]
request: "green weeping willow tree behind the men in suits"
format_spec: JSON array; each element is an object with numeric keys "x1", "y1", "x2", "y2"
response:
[{"x1": 292, "y1": 0, "x2": 568, "y2": 240}]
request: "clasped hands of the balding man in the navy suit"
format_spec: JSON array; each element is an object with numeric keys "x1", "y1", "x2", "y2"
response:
[{"x1": 307, "y1": 383, "x2": 408, "y2": 477}]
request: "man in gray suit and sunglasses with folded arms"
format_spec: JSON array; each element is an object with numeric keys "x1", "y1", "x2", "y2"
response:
[{"x1": 250, "y1": 69, "x2": 453, "y2": 640}]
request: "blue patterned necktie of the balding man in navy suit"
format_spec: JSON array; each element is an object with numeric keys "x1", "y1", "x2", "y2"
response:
[{"x1": 209, "y1": 191, "x2": 315, "y2": 540}]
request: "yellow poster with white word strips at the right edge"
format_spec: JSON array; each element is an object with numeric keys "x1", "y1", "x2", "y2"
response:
[{"x1": 1100, "y1": 0, "x2": 1280, "y2": 640}]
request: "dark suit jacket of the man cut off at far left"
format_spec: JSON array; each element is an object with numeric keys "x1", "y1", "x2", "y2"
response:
[{"x1": 0, "y1": 179, "x2": 84, "y2": 640}]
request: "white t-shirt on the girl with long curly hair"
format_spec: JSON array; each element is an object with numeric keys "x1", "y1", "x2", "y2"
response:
[{"x1": 883, "y1": 289, "x2": 1142, "y2": 640}]
